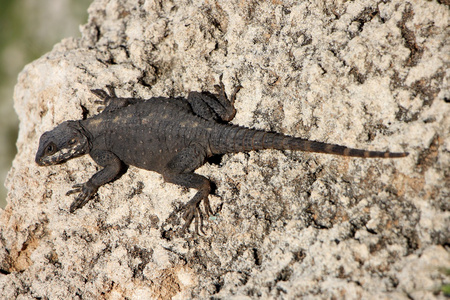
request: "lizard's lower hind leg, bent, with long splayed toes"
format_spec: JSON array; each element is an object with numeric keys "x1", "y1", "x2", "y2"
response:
[{"x1": 163, "y1": 146, "x2": 213, "y2": 235}]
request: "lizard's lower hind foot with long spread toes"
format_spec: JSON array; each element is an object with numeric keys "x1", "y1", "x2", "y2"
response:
[{"x1": 180, "y1": 194, "x2": 213, "y2": 235}]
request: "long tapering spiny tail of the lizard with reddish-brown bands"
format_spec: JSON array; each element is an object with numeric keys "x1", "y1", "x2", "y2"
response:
[{"x1": 212, "y1": 126, "x2": 408, "y2": 158}]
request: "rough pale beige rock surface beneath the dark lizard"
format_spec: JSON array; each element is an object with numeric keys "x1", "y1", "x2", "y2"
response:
[{"x1": 0, "y1": 0, "x2": 450, "y2": 299}]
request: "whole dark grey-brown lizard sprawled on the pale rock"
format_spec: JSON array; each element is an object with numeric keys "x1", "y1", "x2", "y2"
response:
[{"x1": 35, "y1": 76, "x2": 408, "y2": 234}]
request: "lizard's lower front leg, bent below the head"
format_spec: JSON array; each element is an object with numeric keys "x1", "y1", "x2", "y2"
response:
[{"x1": 66, "y1": 150, "x2": 123, "y2": 213}]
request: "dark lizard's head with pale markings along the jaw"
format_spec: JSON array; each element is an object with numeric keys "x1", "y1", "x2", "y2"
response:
[{"x1": 36, "y1": 121, "x2": 90, "y2": 166}]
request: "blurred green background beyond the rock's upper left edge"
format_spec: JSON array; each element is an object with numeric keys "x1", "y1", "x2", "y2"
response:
[{"x1": 0, "y1": 0, "x2": 92, "y2": 208}]
